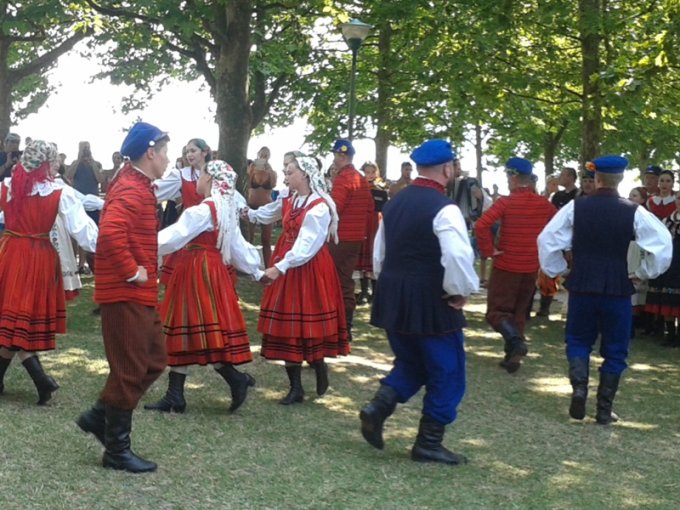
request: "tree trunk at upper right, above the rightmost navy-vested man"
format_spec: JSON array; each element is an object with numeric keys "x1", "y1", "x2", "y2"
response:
[{"x1": 579, "y1": 0, "x2": 602, "y2": 166}]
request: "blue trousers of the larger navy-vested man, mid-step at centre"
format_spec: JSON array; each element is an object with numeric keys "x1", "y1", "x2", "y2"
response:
[{"x1": 381, "y1": 330, "x2": 465, "y2": 425}]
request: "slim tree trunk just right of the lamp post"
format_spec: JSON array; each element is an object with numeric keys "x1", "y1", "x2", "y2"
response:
[{"x1": 375, "y1": 22, "x2": 392, "y2": 179}]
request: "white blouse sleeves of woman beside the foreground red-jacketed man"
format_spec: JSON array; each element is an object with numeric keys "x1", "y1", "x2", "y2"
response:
[{"x1": 158, "y1": 202, "x2": 264, "y2": 280}]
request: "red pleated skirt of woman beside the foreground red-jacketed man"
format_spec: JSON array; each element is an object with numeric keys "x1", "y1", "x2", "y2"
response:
[{"x1": 160, "y1": 243, "x2": 253, "y2": 366}]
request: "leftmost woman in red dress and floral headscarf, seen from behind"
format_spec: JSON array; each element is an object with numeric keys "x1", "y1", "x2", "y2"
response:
[{"x1": 0, "y1": 140, "x2": 97, "y2": 405}]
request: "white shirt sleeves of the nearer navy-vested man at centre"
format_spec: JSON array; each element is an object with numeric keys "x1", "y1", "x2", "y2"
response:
[{"x1": 373, "y1": 204, "x2": 479, "y2": 297}]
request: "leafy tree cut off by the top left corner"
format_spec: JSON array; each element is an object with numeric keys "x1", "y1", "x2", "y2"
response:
[{"x1": 0, "y1": 0, "x2": 92, "y2": 140}]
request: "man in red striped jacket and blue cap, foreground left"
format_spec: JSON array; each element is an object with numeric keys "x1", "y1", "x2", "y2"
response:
[{"x1": 76, "y1": 122, "x2": 169, "y2": 473}]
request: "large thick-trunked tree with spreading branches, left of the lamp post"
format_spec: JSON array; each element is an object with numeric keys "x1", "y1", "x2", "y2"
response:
[{"x1": 86, "y1": 0, "x2": 323, "y2": 183}]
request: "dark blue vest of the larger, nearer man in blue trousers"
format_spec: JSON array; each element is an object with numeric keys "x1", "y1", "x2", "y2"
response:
[{"x1": 371, "y1": 186, "x2": 465, "y2": 335}]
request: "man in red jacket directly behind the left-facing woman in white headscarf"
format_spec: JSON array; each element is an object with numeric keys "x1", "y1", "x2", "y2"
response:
[{"x1": 328, "y1": 139, "x2": 373, "y2": 341}]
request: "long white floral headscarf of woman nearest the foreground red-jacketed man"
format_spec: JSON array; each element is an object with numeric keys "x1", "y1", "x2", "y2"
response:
[{"x1": 205, "y1": 159, "x2": 239, "y2": 264}]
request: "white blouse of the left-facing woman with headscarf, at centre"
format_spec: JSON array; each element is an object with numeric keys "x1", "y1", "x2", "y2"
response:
[{"x1": 248, "y1": 193, "x2": 331, "y2": 274}]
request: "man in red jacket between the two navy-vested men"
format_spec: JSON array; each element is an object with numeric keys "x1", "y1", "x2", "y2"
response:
[{"x1": 475, "y1": 158, "x2": 557, "y2": 374}]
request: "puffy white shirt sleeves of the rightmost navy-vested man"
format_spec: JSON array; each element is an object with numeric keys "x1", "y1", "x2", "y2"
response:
[{"x1": 537, "y1": 200, "x2": 673, "y2": 280}]
